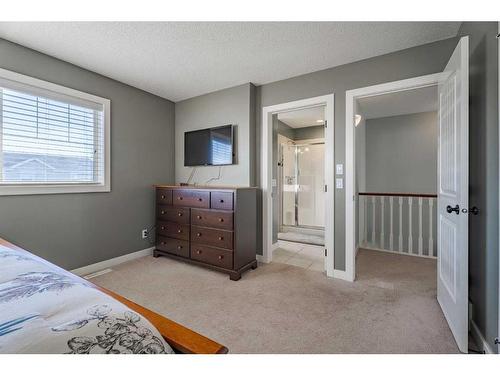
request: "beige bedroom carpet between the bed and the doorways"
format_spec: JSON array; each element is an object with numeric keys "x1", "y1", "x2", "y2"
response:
[{"x1": 92, "y1": 250, "x2": 458, "y2": 353}]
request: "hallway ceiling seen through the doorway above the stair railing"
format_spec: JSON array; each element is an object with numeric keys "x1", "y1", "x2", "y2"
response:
[{"x1": 358, "y1": 86, "x2": 438, "y2": 119}]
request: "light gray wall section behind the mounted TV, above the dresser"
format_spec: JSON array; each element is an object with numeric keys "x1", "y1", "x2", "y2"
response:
[{"x1": 175, "y1": 83, "x2": 256, "y2": 186}]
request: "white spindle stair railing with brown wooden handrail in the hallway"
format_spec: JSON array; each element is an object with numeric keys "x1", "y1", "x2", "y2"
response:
[{"x1": 358, "y1": 193, "x2": 437, "y2": 258}]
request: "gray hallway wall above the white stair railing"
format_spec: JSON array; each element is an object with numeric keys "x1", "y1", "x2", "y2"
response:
[{"x1": 366, "y1": 112, "x2": 438, "y2": 194}]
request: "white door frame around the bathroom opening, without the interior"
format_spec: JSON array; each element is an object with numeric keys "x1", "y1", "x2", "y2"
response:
[{"x1": 261, "y1": 93, "x2": 335, "y2": 277}]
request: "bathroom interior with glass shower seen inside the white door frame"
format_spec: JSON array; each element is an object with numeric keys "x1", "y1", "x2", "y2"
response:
[{"x1": 273, "y1": 106, "x2": 325, "y2": 271}]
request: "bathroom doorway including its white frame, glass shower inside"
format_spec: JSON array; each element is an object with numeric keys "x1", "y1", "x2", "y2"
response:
[{"x1": 261, "y1": 94, "x2": 334, "y2": 277}]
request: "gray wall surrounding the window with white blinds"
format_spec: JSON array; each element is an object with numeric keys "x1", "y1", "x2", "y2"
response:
[{"x1": 0, "y1": 39, "x2": 174, "y2": 269}]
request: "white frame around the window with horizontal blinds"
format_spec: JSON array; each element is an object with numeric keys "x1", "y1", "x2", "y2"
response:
[{"x1": 0, "y1": 68, "x2": 111, "y2": 196}]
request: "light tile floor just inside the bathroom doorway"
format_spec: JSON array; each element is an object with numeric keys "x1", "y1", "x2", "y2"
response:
[{"x1": 273, "y1": 240, "x2": 325, "y2": 272}]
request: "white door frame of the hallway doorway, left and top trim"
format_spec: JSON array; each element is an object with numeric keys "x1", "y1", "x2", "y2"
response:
[{"x1": 345, "y1": 73, "x2": 445, "y2": 281}]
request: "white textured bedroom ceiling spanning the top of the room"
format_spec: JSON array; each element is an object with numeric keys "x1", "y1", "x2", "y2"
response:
[{"x1": 0, "y1": 22, "x2": 460, "y2": 101}]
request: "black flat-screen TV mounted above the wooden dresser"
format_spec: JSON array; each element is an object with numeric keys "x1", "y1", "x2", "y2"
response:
[{"x1": 184, "y1": 125, "x2": 233, "y2": 167}]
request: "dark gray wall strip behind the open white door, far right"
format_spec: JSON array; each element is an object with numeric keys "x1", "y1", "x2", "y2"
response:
[{"x1": 459, "y1": 22, "x2": 499, "y2": 350}]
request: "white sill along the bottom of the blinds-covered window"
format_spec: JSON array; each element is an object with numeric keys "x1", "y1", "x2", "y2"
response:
[{"x1": 0, "y1": 183, "x2": 111, "y2": 196}]
